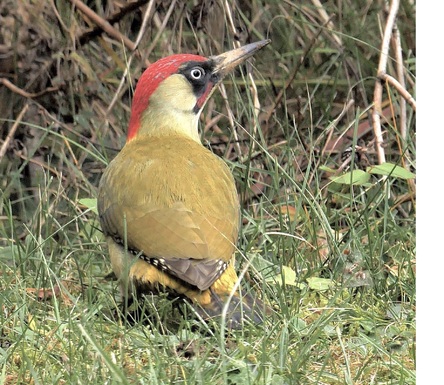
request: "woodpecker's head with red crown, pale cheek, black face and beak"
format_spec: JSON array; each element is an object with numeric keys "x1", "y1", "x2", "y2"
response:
[{"x1": 127, "y1": 40, "x2": 270, "y2": 142}]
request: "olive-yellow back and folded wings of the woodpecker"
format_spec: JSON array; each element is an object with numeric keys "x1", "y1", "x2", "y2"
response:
[{"x1": 98, "y1": 135, "x2": 239, "y2": 288}]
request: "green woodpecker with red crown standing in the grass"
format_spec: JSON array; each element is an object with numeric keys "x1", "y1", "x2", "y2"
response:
[{"x1": 97, "y1": 40, "x2": 270, "y2": 329}]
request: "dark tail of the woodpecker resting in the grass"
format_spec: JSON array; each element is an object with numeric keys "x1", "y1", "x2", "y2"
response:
[{"x1": 192, "y1": 288, "x2": 269, "y2": 329}]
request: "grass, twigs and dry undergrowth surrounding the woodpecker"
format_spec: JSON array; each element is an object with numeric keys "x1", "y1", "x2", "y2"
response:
[{"x1": 0, "y1": 0, "x2": 416, "y2": 384}]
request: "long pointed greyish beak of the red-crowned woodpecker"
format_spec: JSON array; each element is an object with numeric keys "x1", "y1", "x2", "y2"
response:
[{"x1": 210, "y1": 39, "x2": 271, "y2": 80}]
